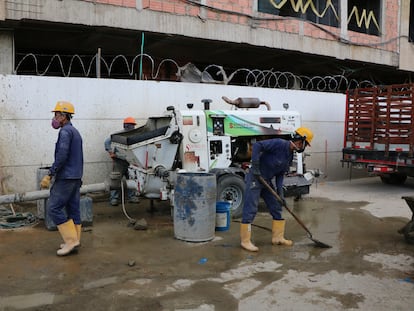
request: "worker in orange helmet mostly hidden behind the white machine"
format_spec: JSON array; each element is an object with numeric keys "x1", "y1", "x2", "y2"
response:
[{"x1": 105, "y1": 117, "x2": 139, "y2": 206}]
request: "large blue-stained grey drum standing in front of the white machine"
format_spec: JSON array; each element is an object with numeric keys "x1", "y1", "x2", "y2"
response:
[{"x1": 174, "y1": 173, "x2": 217, "y2": 242}]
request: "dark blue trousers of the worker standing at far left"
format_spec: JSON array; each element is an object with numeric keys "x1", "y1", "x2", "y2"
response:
[{"x1": 48, "y1": 179, "x2": 82, "y2": 225}]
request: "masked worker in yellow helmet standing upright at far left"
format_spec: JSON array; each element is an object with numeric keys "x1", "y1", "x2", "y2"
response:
[{"x1": 40, "y1": 101, "x2": 83, "y2": 256}]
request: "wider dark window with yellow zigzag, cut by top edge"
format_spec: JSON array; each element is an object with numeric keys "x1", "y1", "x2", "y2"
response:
[{"x1": 257, "y1": 0, "x2": 340, "y2": 27}]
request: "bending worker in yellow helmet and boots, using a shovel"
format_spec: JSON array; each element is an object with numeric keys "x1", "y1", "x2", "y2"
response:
[{"x1": 240, "y1": 127, "x2": 313, "y2": 252}]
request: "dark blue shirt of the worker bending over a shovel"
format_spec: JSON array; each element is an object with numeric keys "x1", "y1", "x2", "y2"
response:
[{"x1": 252, "y1": 138, "x2": 293, "y2": 189}]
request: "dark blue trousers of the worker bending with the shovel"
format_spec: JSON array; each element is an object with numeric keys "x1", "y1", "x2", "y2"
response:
[{"x1": 242, "y1": 172, "x2": 283, "y2": 224}]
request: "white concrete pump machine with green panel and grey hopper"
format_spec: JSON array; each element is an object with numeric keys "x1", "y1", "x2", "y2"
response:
[{"x1": 111, "y1": 96, "x2": 314, "y2": 218}]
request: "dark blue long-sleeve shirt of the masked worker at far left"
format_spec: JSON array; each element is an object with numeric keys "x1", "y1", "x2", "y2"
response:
[{"x1": 49, "y1": 122, "x2": 83, "y2": 179}]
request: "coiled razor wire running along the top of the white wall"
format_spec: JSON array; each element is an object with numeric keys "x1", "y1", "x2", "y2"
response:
[{"x1": 13, "y1": 53, "x2": 377, "y2": 93}]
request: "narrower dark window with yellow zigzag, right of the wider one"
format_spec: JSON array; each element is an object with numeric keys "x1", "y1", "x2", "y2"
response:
[{"x1": 348, "y1": 0, "x2": 381, "y2": 36}]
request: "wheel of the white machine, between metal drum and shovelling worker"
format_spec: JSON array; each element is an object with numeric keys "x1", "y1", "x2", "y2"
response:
[{"x1": 217, "y1": 174, "x2": 245, "y2": 218}]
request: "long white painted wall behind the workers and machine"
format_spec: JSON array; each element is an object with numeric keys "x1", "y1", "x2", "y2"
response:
[{"x1": 0, "y1": 75, "x2": 348, "y2": 192}]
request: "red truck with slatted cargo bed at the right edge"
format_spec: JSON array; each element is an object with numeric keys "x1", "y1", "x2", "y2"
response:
[{"x1": 341, "y1": 83, "x2": 414, "y2": 184}]
